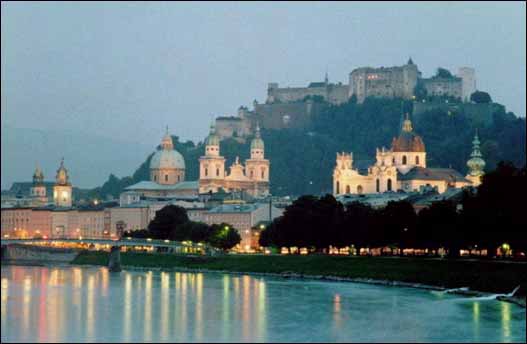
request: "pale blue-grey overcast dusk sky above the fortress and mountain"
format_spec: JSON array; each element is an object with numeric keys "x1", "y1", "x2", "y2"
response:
[{"x1": 1, "y1": 2, "x2": 526, "y2": 146}]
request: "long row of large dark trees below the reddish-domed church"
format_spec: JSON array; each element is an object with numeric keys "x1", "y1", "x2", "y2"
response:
[{"x1": 260, "y1": 164, "x2": 527, "y2": 255}]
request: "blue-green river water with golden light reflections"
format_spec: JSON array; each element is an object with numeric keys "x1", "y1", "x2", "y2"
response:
[{"x1": 1, "y1": 266, "x2": 526, "y2": 342}]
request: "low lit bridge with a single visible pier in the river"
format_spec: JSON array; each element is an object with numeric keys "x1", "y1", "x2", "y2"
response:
[{"x1": 1, "y1": 237, "x2": 211, "y2": 272}]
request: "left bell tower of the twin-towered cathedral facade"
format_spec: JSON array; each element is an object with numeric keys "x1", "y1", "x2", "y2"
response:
[{"x1": 199, "y1": 124, "x2": 225, "y2": 193}]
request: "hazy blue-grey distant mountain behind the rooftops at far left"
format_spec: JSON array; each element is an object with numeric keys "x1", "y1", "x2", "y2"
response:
[{"x1": 1, "y1": 125, "x2": 155, "y2": 190}]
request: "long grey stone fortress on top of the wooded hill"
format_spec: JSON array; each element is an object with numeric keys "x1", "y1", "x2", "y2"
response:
[{"x1": 216, "y1": 58, "x2": 476, "y2": 140}]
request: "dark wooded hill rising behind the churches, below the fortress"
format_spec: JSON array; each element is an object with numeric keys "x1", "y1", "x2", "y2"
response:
[{"x1": 93, "y1": 98, "x2": 526, "y2": 197}]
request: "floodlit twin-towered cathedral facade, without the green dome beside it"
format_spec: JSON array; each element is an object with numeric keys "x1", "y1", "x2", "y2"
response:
[{"x1": 199, "y1": 125, "x2": 269, "y2": 197}]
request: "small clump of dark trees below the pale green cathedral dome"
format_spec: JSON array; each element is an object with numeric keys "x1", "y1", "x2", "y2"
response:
[{"x1": 124, "y1": 205, "x2": 241, "y2": 250}]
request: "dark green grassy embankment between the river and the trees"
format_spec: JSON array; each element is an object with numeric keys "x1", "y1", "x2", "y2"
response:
[{"x1": 72, "y1": 252, "x2": 527, "y2": 296}]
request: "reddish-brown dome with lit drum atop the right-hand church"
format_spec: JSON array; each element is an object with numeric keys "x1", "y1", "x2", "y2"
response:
[{"x1": 392, "y1": 114, "x2": 426, "y2": 174}]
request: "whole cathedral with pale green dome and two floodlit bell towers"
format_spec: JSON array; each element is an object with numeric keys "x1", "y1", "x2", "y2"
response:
[{"x1": 120, "y1": 126, "x2": 269, "y2": 206}]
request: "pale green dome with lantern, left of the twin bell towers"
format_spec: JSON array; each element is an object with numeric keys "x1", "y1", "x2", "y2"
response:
[{"x1": 150, "y1": 127, "x2": 185, "y2": 185}]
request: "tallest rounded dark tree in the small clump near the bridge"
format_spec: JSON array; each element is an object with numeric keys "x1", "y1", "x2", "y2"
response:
[{"x1": 148, "y1": 205, "x2": 188, "y2": 239}]
